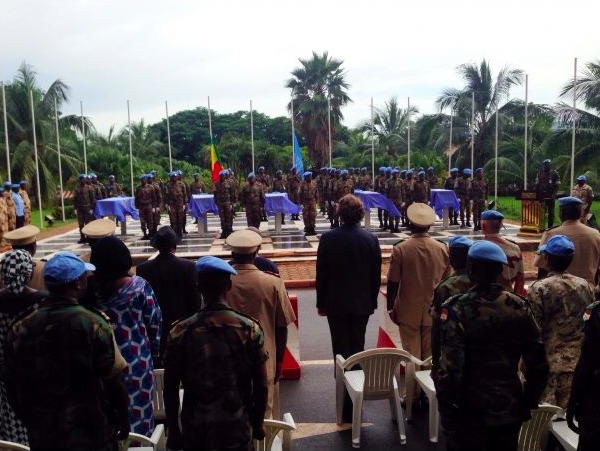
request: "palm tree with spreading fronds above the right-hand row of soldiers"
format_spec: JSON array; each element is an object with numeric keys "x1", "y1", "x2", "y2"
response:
[{"x1": 436, "y1": 60, "x2": 523, "y2": 167}]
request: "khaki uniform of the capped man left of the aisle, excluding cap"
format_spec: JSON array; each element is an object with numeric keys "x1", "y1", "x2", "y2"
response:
[{"x1": 226, "y1": 264, "x2": 296, "y2": 418}]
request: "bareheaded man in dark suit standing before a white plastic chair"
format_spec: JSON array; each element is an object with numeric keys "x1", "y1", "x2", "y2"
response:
[{"x1": 316, "y1": 194, "x2": 381, "y2": 422}]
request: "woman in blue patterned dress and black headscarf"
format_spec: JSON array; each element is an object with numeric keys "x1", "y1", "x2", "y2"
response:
[{"x1": 90, "y1": 236, "x2": 162, "y2": 437}]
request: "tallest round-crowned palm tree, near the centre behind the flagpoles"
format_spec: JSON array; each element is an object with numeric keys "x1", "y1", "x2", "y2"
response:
[{"x1": 285, "y1": 52, "x2": 351, "y2": 167}]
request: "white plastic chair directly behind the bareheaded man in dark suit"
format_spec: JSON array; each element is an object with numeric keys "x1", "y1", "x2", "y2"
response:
[{"x1": 335, "y1": 348, "x2": 413, "y2": 448}]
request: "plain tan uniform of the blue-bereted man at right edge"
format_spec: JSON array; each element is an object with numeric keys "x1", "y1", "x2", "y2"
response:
[{"x1": 533, "y1": 220, "x2": 600, "y2": 285}]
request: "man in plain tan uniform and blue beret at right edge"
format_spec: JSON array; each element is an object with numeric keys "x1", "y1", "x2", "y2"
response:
[{"x1": 533, "y1": 196, "x2": 600, "y2": 285}]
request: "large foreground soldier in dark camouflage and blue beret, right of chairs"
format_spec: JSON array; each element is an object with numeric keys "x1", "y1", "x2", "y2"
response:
[{"x1": 437, "y1": 241, "x2": 548, "y2": 451}]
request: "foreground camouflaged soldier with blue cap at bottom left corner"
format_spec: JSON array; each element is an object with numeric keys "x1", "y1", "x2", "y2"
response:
[{"x1": 3, "y1": 252, "x2": 130, "y2": 451}]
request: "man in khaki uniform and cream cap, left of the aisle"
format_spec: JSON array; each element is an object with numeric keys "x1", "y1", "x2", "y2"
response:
[{"x1": 225, "y1": 230, "x2": 296, "y2": 419}]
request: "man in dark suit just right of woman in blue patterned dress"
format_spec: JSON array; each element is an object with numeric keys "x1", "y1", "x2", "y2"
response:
[{"x1": 136, "y1": 226, "x2": 200, "y2": 367}]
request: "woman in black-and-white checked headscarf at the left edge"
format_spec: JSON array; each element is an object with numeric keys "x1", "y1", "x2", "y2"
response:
[{"x1": 0, "y1": 249, "x2": 45, "y2": 445}]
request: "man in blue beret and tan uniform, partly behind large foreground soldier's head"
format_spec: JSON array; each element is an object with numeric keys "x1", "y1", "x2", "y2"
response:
[{"x1": 481, "y1": 210, "x2": 525, "y2": 296}]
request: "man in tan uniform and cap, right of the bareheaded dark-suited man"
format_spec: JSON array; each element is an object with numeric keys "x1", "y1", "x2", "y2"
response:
[{"x1": 387, "y1": 203, "x2": 451, "y2": 400}]
